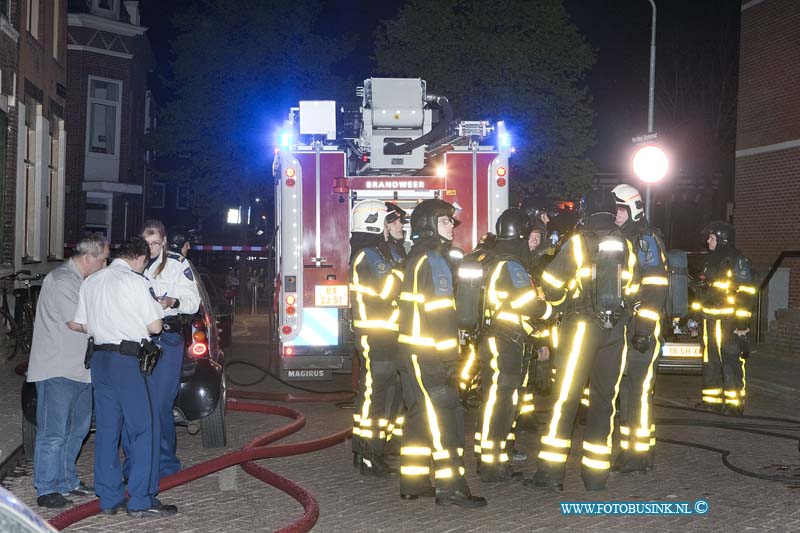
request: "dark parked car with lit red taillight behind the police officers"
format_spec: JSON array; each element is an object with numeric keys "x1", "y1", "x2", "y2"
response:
[{"x1": 21, "y1": 267, "x2": 230, "y2": 460}]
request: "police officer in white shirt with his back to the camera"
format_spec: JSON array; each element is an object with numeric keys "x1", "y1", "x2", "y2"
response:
[{"x1": 69, "y1": 237, "x2": 178, "y2": 518}]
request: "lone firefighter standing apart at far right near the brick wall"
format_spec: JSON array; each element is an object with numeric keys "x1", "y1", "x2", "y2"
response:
[{"x1": 692, "y1": 221, "x2": 757, "y2": 416}]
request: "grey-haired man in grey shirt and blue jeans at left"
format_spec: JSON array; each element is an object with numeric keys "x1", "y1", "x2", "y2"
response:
[{"x1": 27, "y1": 233, "x2": 108, "y2": 509}]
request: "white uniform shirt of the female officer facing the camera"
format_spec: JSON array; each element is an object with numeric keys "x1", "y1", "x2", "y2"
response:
[{"x1": 144, "y1": 252, "x2": 200, "y2": 316}]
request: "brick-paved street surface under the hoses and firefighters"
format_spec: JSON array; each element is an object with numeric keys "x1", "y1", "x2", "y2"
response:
[{"x1": 0, "y1": 316, "x2": 800, "y2": 533}]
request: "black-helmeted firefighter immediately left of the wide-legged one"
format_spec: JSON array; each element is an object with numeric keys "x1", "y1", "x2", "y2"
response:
[{"x1": 476, "y1": 208, "x2": 552, "y2": 482}]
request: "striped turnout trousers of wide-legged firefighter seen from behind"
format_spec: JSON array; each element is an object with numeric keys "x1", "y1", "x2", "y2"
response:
[{"x1": 536, "y1": 314, "x2": 627, "y2": 489}]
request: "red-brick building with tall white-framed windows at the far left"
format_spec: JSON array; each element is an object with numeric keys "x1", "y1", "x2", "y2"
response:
[{"x1": 11, "y1": 0, "x2": 67, "y2": 273}]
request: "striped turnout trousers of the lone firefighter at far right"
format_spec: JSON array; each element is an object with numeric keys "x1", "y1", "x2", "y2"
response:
[{"x1": 703, "y1": 318, "x2": 746, "y2": 409}]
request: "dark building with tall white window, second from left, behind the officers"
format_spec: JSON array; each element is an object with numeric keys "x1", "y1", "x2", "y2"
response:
[{"x1": 65, "y1": 0, "x2": 153, "y2": 243}]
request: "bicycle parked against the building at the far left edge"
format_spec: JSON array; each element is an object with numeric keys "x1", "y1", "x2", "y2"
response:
[{"x1": 0, "y1": 270, "x2": 44, "y2": 360}]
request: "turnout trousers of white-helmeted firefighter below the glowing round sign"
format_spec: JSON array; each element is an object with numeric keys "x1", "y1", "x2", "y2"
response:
[{"x1": 617, "y1": 321, "x2": 661, "y2": 470}]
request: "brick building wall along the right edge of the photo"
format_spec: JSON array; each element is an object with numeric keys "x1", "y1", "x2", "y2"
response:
[{"x1": 734, "y1": 0, "x2": 800, "y2": 352}]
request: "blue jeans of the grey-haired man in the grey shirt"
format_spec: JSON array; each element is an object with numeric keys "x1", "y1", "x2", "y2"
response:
[{"x1": 33, "y1": 378, "x2": 92, "y2": 496}]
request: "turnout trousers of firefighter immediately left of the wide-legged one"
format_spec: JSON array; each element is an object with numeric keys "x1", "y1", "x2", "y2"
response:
[{"x1": 475, "y1": 335, "x2": 525, "y2": 477}]
